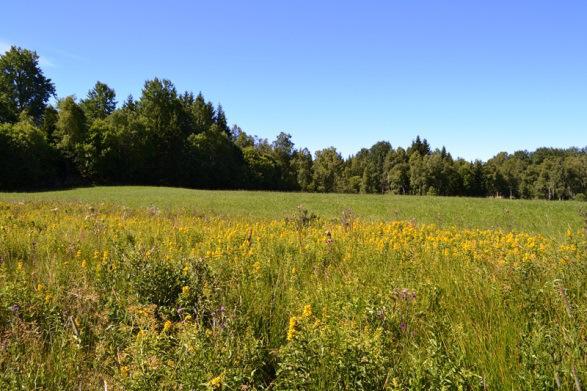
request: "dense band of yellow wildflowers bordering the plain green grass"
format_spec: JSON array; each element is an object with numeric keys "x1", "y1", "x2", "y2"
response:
[{"x1": 6, "y1": 202, "x2": 585, "y2": 284}]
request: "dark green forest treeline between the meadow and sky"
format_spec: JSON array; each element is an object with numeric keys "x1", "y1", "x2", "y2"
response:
[{"x1": 0, "y1": 46, "x2": 587, "y2": 200}]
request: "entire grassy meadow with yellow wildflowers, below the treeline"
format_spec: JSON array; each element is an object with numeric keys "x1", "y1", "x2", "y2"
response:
[{"x1": 0, "y1": 187, "x2": 587, "y2": 390}]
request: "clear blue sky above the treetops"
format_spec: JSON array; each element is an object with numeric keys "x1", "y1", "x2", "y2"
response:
[{"x1": 0, "y1": 0, "x2": 587, "y2": 159}]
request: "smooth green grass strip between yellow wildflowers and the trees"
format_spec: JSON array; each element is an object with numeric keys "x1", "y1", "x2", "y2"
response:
[{"x1": 0, "y1": 186, "x2": 587, "y2": 238}]
